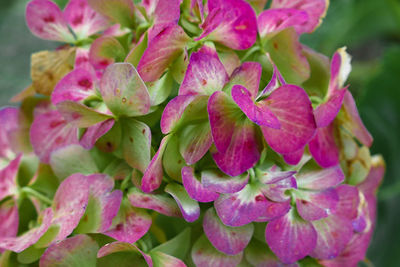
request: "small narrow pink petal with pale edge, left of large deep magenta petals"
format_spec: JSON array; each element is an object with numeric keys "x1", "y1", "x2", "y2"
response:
[{"x1": 160, "y1": 95, "x2": 196, "y2": 134}]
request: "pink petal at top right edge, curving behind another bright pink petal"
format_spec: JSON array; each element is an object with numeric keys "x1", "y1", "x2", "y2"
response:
[{"x1": 271, "y1": 0, "x2": 329, "y2": 33}]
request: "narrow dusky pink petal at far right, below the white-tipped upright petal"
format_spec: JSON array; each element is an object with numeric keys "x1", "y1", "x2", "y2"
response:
[{"x1": 343, "y1": 90, "x2": 373, "y2": 147}]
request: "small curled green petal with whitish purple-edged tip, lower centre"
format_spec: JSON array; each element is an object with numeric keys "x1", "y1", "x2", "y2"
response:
[{"x1": 165, "y1": 183, "x2": 200, "y2": 222}]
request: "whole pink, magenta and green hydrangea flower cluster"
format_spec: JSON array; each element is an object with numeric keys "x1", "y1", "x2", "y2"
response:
[{"x1": 0, "y1": 0, "x2": 385, "y2": 267}]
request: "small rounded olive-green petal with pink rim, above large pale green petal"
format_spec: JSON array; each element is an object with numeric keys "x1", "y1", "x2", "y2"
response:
[{"x1": 89, "y1": 36, "x2": 125, "y2": 70}]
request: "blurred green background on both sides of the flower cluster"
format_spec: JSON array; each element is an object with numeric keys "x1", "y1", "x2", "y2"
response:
[{"x1": 0, "y1": 0, "x2": 400, "y2": 267}]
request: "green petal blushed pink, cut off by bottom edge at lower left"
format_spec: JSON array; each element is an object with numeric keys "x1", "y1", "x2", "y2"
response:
[{"x1": 39, "y1": 235, "x2": 99, "y2": 267}]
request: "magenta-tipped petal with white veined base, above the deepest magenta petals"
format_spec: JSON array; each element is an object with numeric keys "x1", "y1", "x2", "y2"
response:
[{"x1": 179, "y1": 46, "x2": 228, "y2": 95}]
